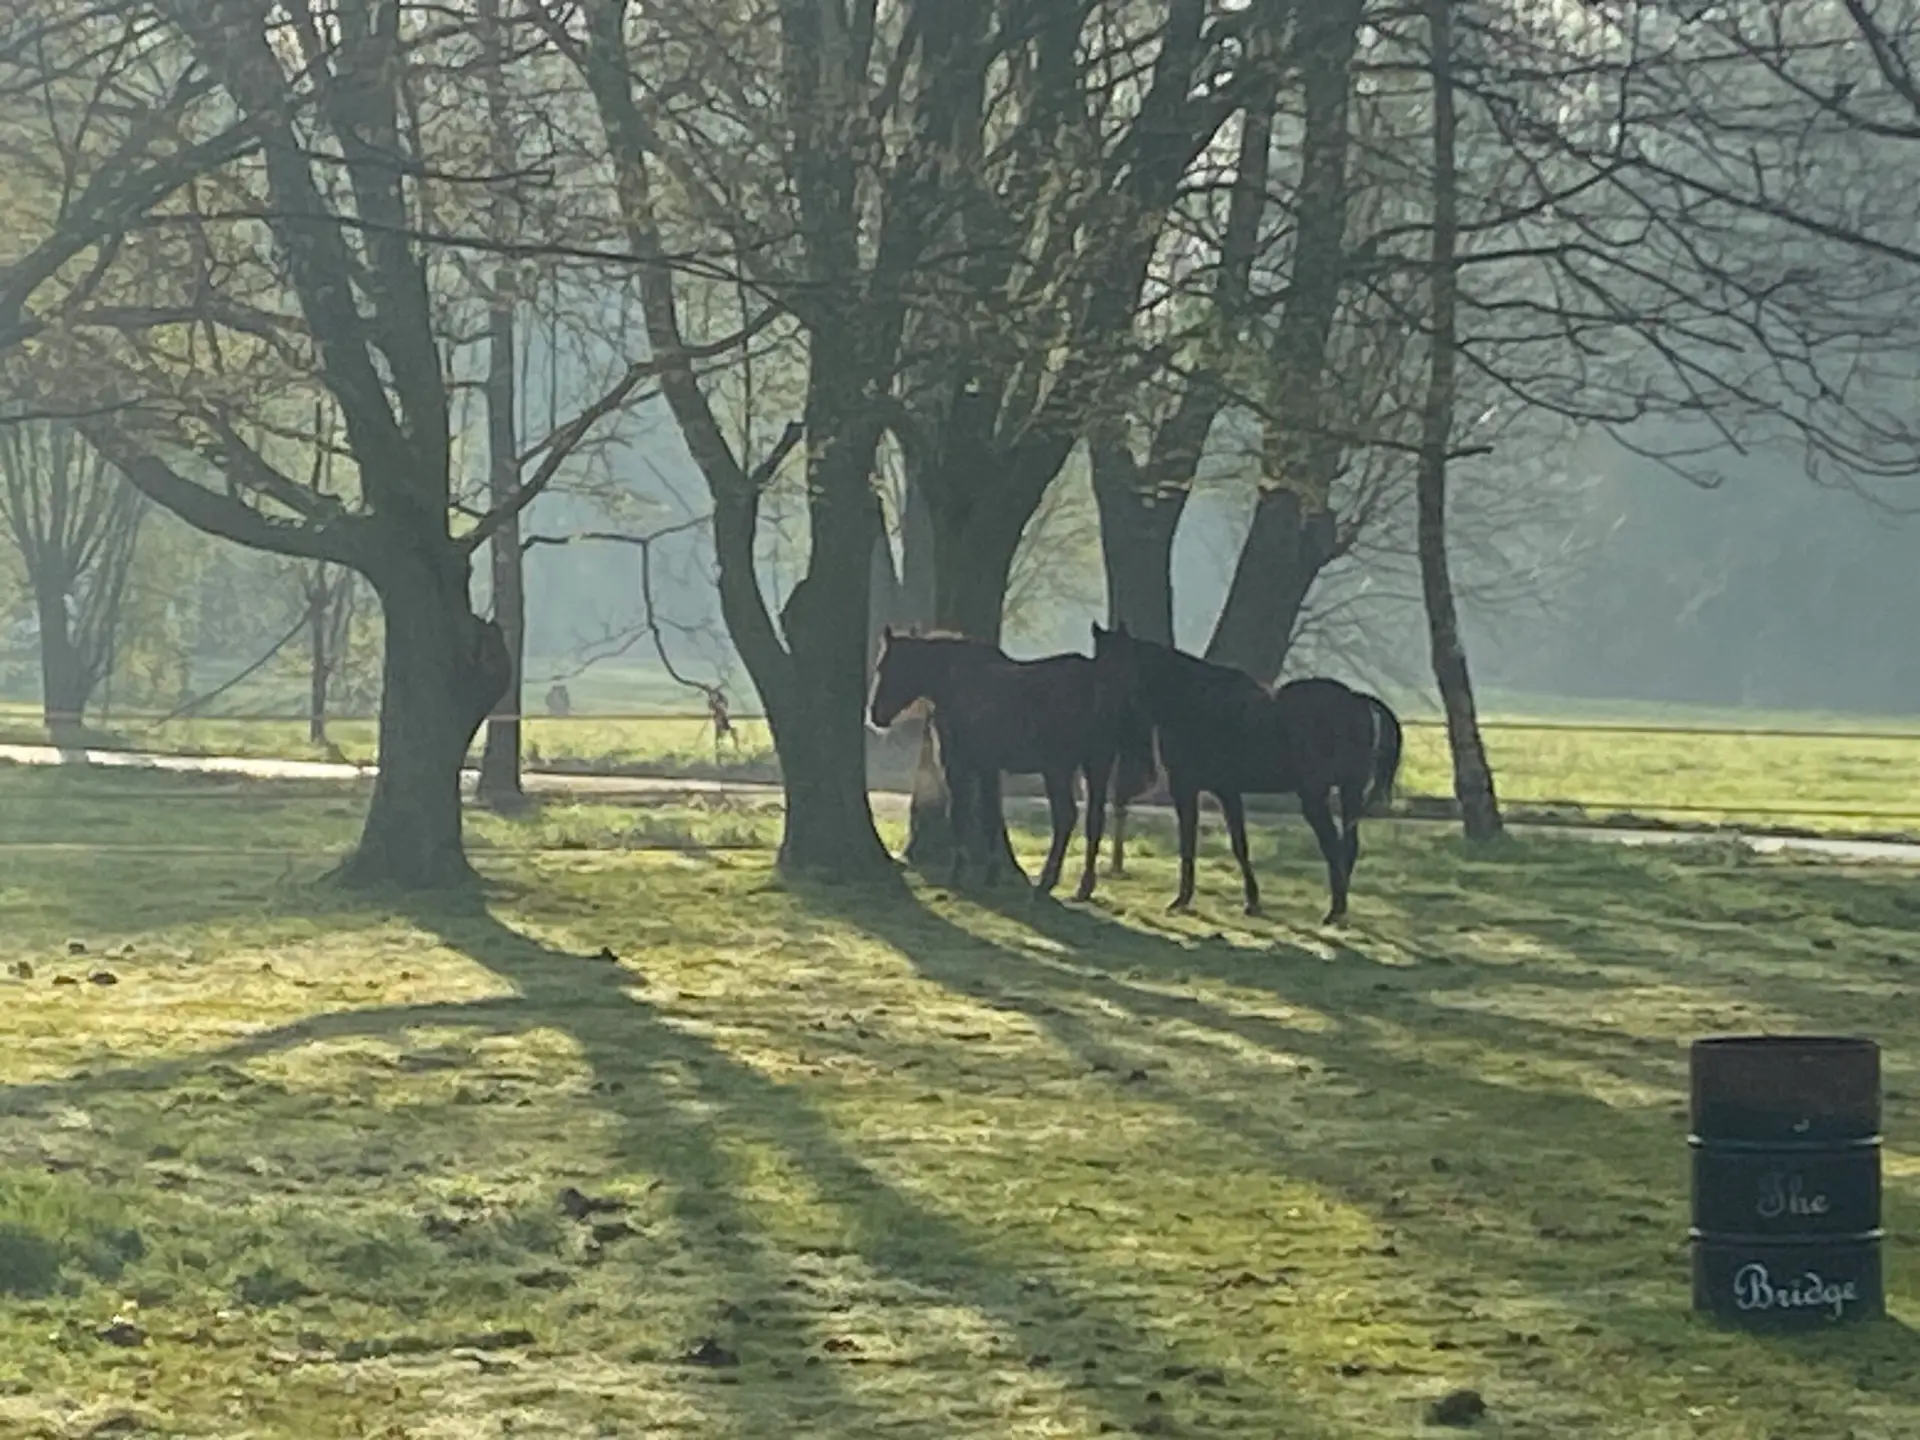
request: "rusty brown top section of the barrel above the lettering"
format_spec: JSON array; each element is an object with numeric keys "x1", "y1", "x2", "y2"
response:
[{"x1": 1690, "y1": 1035, "x2": 1880, "y2": 1142}]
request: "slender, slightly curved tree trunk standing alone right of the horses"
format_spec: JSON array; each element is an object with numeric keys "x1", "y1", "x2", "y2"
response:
[{"x1": 1419, "y1": 0, "x2": 1501, "y2": 841}]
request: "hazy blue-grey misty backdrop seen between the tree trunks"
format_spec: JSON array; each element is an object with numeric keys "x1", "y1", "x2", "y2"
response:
[{"x1": 0, "y1": 346, "x2": 1920, "y2": 722}]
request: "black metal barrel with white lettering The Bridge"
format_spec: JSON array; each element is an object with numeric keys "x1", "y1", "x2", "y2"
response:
[{"x1": 1688, "y1": 1035, "x2": 1885, "y2": 1331}]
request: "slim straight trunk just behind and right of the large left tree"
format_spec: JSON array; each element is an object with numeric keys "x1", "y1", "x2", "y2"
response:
[{"x1": 478, "y1": 300, "x2": 526, "y2": 810}]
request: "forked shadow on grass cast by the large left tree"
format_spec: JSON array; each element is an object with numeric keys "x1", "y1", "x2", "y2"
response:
[{"x1": 0, "y1": 879, "x2": 1344, "y2": 1440}]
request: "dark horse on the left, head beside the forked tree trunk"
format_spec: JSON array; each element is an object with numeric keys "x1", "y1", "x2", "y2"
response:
[{"x1": 868, "y1": 628, "x2": 1152, "y2": 900}]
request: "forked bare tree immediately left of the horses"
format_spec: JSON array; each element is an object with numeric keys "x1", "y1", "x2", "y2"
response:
[{"x1": 547, "y1": 0, "x2": 970, "y2": 877}]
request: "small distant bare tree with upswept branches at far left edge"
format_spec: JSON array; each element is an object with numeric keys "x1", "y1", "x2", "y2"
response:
[{"x1": 0, "y1": 420, "x2": 146, "y2": 743}]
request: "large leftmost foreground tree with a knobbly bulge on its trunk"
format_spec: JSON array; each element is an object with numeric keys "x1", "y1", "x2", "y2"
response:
[{"x1": 0, "y1": 0, "x2": 691, "y2": 887}]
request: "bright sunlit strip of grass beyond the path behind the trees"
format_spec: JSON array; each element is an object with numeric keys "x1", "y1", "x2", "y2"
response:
[{"x1": 0, "y1": 707, "x2": 1920, "y2": 833}]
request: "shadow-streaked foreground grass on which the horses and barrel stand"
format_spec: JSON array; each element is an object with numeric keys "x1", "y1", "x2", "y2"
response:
[{"x1": 0, "y1": 768, "x2": 1920, "y2": 1440}]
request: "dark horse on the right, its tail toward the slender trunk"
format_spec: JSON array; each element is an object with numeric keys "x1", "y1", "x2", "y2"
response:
[{"x1": 1092, "y1": 626, "x2": 1400, "y2": 924}]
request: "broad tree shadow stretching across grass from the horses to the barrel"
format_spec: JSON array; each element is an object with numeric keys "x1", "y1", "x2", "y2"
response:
[{"x1": 816, "y1": 879, "x2": 1920, "y2": 1419}]
